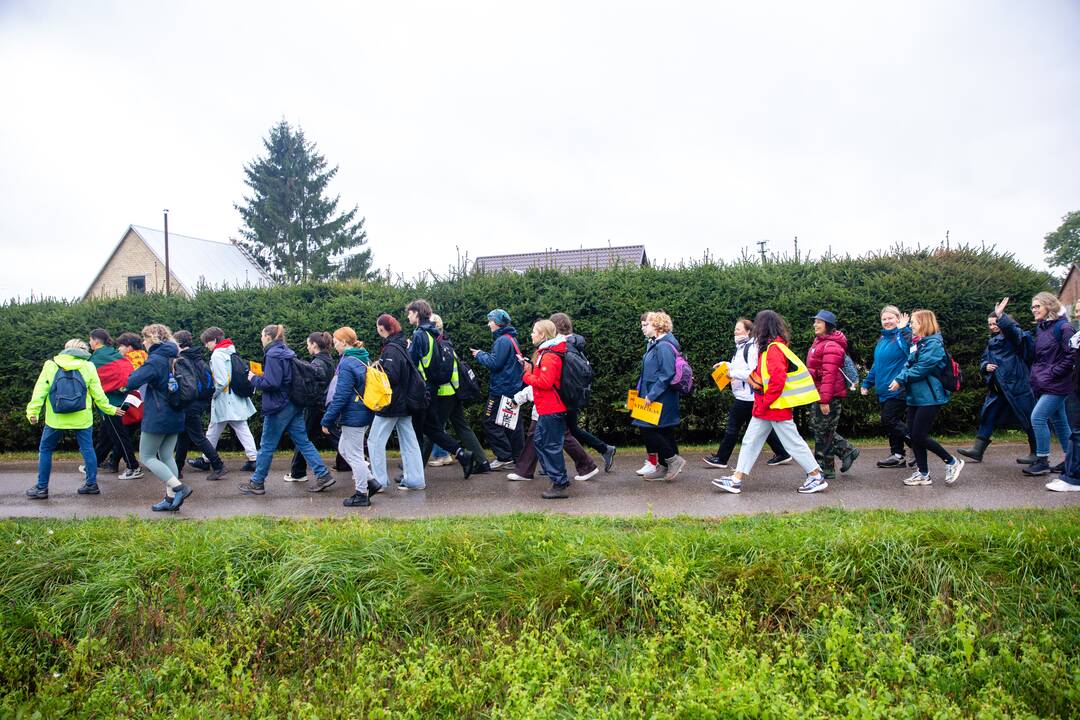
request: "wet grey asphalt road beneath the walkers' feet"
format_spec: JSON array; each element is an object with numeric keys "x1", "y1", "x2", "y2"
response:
[{"x1": 0, "y1": 444, "x2": 1080, "y2": 519}]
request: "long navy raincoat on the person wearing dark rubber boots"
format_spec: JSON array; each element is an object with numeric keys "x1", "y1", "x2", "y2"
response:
[{"x1": 978, "y1": 313, "x2": 1035, "y2": 430}]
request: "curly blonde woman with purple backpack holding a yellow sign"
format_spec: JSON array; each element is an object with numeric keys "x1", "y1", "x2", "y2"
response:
[{"x1": 632, "y1": 311, "x2": 686, "y2": 483}]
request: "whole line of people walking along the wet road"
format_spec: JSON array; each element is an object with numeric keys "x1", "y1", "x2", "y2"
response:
[{"x1": 26, "y1": 293, "x2": 1080, "y2": 512}]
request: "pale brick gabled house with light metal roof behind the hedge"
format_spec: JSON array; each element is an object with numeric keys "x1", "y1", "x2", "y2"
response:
[{"x1": 83, "y1": 225, "x2": 273, "y2": 300}]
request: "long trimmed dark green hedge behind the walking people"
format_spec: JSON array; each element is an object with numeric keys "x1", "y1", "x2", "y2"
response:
[{"x1": 0, "y1": 248, "x2": 1050, "y2": 450}]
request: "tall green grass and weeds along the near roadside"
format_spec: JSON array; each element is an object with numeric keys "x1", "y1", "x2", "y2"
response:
[{"x1": 0, "y1": 510, "x2": 1080, "y2": 719}]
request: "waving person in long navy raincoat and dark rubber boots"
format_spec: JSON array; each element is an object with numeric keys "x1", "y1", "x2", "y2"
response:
[{"x1": 957, "y1": 298, "x2": 1036, "y2": 464}]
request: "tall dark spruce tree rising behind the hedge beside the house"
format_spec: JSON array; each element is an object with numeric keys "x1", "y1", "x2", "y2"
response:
[{"x1": 234, "y1": 120, "x2": 374, "y2": 283}]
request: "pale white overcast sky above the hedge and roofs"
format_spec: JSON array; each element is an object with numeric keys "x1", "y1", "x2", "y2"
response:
[{"x1": 0, "y1": 0, "x2": 1080, "y2": 298}]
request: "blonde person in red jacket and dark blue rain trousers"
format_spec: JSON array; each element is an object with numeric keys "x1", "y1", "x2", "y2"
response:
[{"x1": 518, "y1": 320, "x2": 570, "y2": 500}]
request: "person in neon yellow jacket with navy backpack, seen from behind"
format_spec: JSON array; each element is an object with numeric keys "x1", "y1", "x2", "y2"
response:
[{"x1": 26, "y1": 339, "x2": 124, "y2": 500}]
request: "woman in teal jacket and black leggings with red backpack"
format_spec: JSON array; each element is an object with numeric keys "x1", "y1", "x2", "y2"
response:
[{"x1": 889, "y1": 310, "x2": 963, "y2": 486}]
